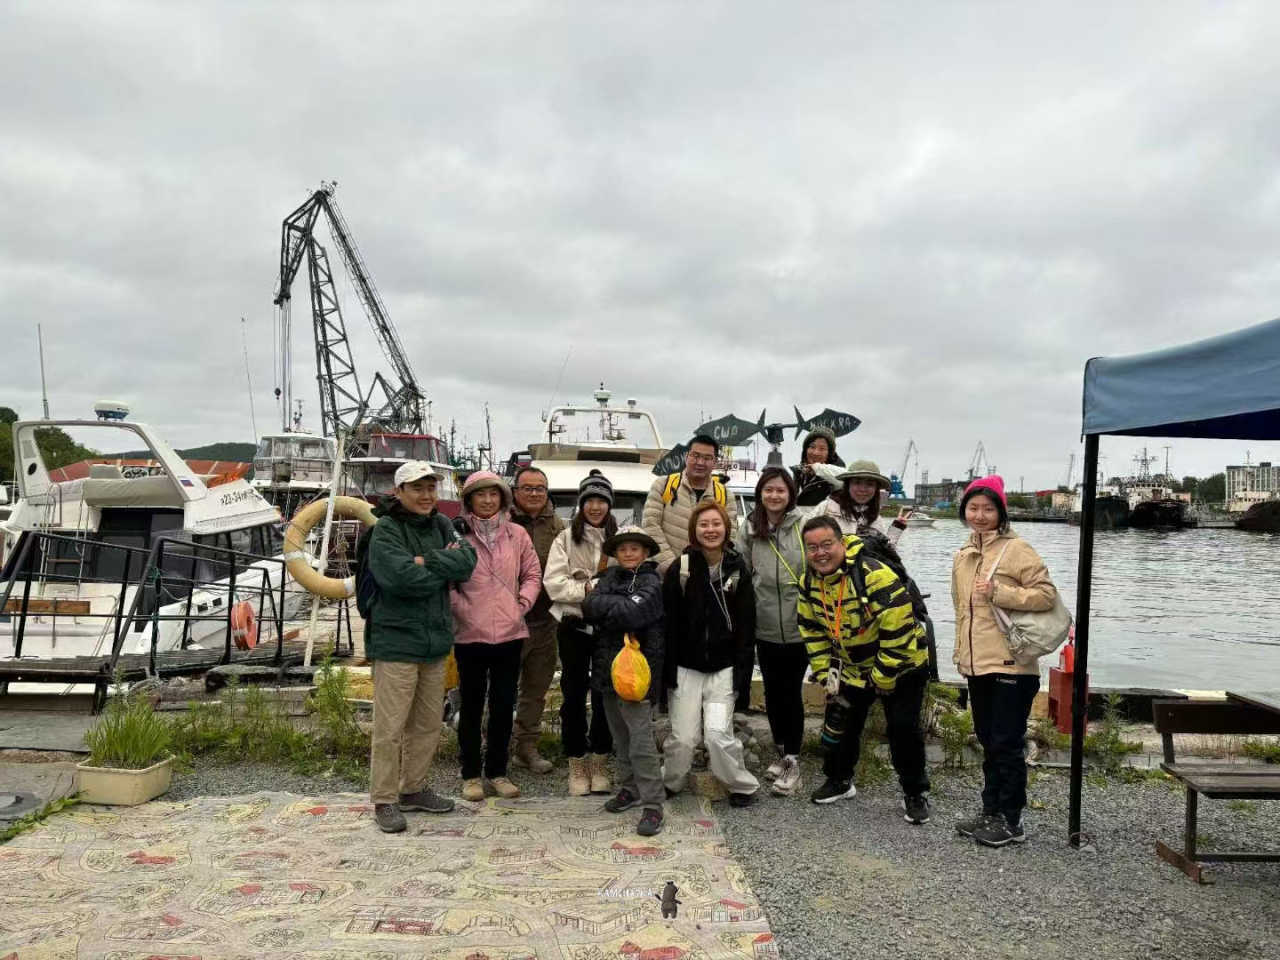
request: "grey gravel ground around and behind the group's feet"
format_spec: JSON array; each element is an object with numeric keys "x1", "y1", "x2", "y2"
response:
[{"x1": 165, "y1": 736, "x2": 1280, "y2": 960}]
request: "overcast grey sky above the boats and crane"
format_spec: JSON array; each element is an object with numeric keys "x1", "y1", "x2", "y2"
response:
[{"x1": 0, "y1": 0, "x2": 1280, "y2": 488}]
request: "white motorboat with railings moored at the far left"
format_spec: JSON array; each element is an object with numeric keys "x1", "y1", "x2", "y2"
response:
[{"x1": 0, "y1": 407, "x2": 302, "y2": 691}]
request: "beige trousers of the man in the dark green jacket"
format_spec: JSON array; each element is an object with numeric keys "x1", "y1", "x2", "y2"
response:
[{"x1": 369, "y1": 659, "x2": 444, "y2": 804}]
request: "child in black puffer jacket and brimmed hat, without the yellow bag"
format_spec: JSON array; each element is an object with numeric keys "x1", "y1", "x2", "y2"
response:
[{"x1": 582, "y1": 526, "x2": 664, "y2": 837}]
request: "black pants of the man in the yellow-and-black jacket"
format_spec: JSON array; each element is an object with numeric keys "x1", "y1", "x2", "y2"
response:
[{"x1": 822, "y1": 668, "x2": 929, "y2": 796}]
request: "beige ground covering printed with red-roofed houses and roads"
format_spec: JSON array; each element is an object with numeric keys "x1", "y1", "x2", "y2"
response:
[{"x1": 0, "y1": 794, "x2": 778, "y2": 960}]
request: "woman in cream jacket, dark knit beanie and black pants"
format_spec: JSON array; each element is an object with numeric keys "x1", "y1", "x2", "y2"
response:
[{"x1": 545, "y1": 470, "x2": 618, "y2": 796}]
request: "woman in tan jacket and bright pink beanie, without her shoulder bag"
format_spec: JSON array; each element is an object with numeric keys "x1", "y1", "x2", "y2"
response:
[{"x1": 951, "y1": 476, "x2": 1057, "y2": 846}]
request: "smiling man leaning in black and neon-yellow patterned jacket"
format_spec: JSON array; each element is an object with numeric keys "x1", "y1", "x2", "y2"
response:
[{"x1": 796, "y1": 516, "x2": 929, "y2": 824}]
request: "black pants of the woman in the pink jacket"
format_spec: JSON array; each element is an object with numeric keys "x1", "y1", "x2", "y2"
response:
[{"x1": 453, "y1": 640, "x2": 525, "y2": 780}]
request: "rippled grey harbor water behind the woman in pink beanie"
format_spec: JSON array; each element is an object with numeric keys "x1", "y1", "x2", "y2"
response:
[{"x1": 899, "y1": 520, "x2": 1280, "y2": 690}]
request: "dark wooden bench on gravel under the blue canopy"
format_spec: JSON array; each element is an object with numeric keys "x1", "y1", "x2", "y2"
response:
[{"x1": 1151, "y1": 700, "x2": 1280, "y2": 883}]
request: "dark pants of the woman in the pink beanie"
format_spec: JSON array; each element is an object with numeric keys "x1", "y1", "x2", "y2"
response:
[{"x1": 969, "y1": 673, "x2": 1039, "y2": 823}]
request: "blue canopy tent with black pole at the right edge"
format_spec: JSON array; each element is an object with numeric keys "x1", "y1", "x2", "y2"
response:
[{"x1": 1069, "y1": 320, "x2": 1280, "y2": 846}]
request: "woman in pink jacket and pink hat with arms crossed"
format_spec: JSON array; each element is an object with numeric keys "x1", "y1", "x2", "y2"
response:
[{"x1": 452, "y1": 470, "x2": 543, "y2": 800}]
